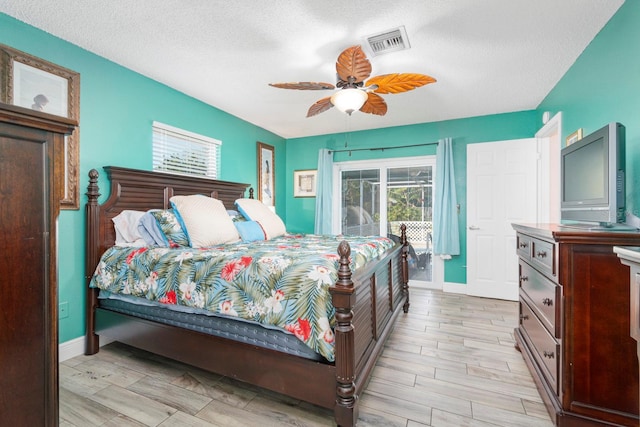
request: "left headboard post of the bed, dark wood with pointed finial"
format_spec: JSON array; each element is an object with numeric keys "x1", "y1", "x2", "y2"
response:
[{"x1": 85, "y1": 169, "x2": 100, "y2": 354}]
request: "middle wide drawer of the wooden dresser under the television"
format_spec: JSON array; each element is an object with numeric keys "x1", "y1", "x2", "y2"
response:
[{"x1": 520, "y1": 261, "x2": 561, "y2": 338}]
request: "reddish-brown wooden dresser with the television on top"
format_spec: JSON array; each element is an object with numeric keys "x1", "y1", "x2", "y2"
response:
[{"x1": 513, "y1": 224, "x2": 640, "y2": 426}]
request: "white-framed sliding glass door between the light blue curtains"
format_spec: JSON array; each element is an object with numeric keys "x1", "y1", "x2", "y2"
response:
[{"x1": 334, "y1": 156, "x2": 435, "y2": 282}]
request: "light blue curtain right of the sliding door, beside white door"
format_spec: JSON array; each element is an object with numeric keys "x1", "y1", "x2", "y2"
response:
[{"x1": 433, "y1": 138, "x2": 460, "y2": 258}]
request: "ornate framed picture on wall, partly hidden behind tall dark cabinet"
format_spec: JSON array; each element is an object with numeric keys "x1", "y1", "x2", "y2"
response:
[{"x1": 0, "y1": 44, "x2": 80, "y2": 209}]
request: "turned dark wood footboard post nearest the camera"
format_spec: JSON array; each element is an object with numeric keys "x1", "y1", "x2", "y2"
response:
[{"x1": 330, "y1": 240, "x2": 358, "y2": 427}]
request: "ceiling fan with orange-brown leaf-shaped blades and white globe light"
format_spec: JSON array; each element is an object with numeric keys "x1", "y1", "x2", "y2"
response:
[{"x1": 269, "y1": 45, "x2": 436, "y2": 117}]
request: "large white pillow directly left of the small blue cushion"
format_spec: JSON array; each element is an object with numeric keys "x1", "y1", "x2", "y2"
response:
[{"x1": 170, "y1": 194, "x2": 240, "y2": 248}]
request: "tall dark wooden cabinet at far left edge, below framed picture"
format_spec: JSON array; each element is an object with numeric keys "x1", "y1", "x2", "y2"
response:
[{"x1": 0, "y1": 104, "x2": 75, "y2": 426}]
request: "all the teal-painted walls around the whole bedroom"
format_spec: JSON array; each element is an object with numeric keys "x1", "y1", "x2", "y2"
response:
[{"x1": 0, "y1": 1, "x2": 640, "y2": 342}]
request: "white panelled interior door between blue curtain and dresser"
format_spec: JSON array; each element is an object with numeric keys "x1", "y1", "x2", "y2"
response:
[{"x1": 467, "y1": 138, "x2": 538, "y2": 301}]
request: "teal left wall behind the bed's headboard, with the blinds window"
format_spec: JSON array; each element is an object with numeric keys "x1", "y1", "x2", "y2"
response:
[{"x1": 0, "y1": 14, "x2": 286, "y2": 342}]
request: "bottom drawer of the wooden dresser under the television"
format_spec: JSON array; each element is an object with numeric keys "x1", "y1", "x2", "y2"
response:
[{"x1": 520, "y1": 301, "x2": 560, "y2": 394}]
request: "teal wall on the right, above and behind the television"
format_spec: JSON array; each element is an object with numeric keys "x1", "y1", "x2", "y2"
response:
[{"x1": 538, "y1": 0, "x2": 640, "y2": 217}]
